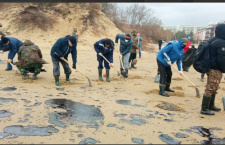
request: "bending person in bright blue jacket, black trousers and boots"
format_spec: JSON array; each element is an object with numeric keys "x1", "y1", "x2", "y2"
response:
[{"x1": 157, "y1": 38, "x2": 188, "y2": 97}]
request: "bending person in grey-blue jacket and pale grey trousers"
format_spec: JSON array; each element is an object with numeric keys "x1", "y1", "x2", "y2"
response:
[{"x1": 115, "y1": 34, "x2": 133, "y2": 78}]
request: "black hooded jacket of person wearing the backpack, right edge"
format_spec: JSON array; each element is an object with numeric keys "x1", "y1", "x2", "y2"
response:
[{"x1": 209, "y1": 24, "x2": 225, "y2": 73}]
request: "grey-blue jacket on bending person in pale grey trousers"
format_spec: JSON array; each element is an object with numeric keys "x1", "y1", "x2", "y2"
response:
[{"x1": 115, "y1": 34, "x2": 133, "y2": 55}]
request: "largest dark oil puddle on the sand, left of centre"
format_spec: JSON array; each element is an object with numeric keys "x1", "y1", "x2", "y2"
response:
[{"x1": 45, "y1": 99, "x2": 104, "y2": 130}]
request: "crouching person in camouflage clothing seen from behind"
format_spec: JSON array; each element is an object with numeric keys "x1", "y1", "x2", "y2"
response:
[{"x1": 17, "y1": 40, "x2": 47, "y2": 80}]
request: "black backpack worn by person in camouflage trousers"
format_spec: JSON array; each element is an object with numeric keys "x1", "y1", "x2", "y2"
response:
[{"x1": 193, "y1": 39, "x2": 218, "y2": 73}]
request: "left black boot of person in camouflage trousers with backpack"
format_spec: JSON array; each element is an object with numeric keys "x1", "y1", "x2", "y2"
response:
[{"x1": 201, "y1": 95, "x2": 215, "y2": 115}]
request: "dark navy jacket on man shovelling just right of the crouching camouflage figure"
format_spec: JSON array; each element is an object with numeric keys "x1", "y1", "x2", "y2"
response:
[{"x1": 51, "y1": 35, "x2": 77, "y2": 64}]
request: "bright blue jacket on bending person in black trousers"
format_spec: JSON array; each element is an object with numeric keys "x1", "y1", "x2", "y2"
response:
[{"x1": 157, "y1": 39, "x2": 184, "y2": 71}]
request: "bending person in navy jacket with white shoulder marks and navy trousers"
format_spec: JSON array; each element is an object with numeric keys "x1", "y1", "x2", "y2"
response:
[{"x1": 94, "y1": 38, "x2": 114, "y2": 82}]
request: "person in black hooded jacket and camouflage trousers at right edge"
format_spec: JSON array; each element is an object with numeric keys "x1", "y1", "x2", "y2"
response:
[{"x1": 201, "y1": 24, "x2": 225, "y2": 115}]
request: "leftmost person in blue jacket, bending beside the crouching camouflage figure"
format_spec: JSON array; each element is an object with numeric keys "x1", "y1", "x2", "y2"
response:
[{"x1": 1, "y1": 36, "x2": 23, "y2": 71}]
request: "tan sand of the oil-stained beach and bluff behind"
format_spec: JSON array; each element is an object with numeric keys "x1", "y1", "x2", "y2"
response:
[{"x1": 0, "y1": 3, "x2": 225, "y2": 144}]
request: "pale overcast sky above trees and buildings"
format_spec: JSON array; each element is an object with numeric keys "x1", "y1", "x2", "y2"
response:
[{"x1": 119, "y1": 3, "x2": 225, "y2": 25}]
